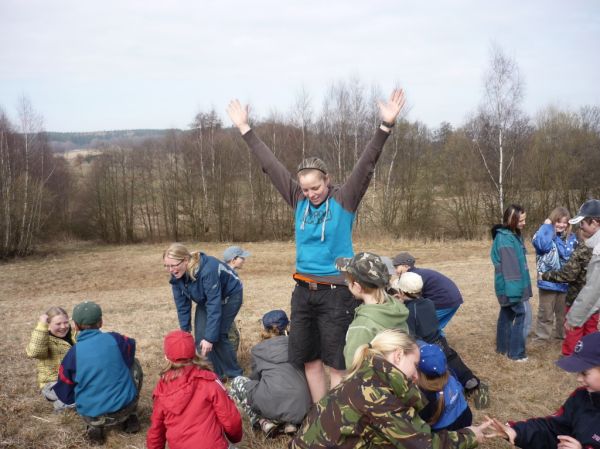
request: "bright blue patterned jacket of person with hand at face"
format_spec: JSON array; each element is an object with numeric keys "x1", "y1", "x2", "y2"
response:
[{"x1": 531, "y1": 224, "x2": 577, "y2": 293}]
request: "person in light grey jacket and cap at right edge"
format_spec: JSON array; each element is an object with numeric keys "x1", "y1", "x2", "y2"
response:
[{"x1": 565, "y1": 199, "x2": 600, "y2": 330}]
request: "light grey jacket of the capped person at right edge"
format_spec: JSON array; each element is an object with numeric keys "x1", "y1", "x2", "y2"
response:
[{"x1": 567, "y1": 231, "x2": 600, "y2": 327}]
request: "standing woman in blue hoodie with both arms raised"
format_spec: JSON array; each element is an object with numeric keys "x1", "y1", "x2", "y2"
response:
[{"x1": 227, "y1": 89, "x2": 404, "y2": 402}]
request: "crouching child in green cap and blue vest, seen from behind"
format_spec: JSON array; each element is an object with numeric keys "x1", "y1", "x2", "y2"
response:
[{"x1": 54, "y1": 301, "x2": 143, "y2": 443}]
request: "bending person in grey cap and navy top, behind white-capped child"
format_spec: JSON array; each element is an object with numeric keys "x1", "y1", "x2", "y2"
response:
[{"x1": 392, "y1": 252, "x2": 463, "y2": 333}]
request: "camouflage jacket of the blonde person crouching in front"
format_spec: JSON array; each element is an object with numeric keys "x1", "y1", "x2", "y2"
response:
[{"x1": 289, "y1": 357, "x2": 477, "y2": 449}]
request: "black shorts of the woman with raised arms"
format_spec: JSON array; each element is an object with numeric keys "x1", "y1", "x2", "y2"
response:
[{"x1": 289, "y1": 285, "x2": 360, "y2": 370}]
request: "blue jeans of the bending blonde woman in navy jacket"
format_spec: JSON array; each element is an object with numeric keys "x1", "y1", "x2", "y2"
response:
[{"x1": 194, "y1": 292, "x2": 244, "y2": 378}]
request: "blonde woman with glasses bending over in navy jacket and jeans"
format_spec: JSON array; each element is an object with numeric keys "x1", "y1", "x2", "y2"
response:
[{"x1": 163, "y1": 243, "x2": 243, "y2": 378}]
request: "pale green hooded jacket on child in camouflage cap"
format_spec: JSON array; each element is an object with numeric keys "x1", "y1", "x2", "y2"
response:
[{"x1": 344, "y1": 293, "x2": 408, "y2": 367}]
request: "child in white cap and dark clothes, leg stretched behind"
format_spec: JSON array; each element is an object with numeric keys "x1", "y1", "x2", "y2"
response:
[{"x1": 392, "y1": 272, "x2": 490, "y2": 409}]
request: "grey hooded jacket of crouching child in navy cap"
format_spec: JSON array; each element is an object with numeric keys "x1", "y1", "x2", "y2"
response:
[{"x1": 246, "y1": 335, "x2": 312, "y2": 424}]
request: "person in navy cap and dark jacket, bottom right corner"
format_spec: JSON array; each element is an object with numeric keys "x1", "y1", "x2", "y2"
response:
[{"x1": 494, "y1": 332, "x2": 600, "y2": 449}]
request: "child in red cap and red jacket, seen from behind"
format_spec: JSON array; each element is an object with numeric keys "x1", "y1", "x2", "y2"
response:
[{"x1": 146, "y1": 330, "x2": 242, "y2": 449}]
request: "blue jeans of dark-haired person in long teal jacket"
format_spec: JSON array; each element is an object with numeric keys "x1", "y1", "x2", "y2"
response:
[{"x1": 496, "y1": 302, "x2": 527, "y2": 360}]
